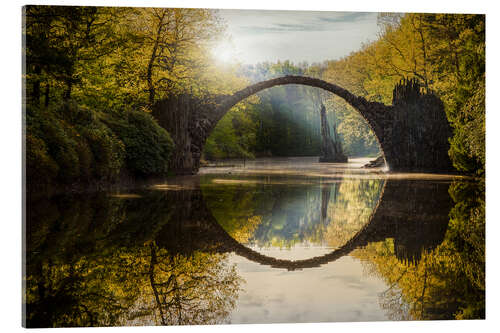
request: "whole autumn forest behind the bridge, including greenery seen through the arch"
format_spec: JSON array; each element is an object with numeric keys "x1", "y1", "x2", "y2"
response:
[{"x1": 23, "y1": 6, "x2": 485, "y2": 186}]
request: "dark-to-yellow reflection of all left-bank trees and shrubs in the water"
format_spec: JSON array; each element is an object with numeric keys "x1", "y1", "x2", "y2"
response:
[{"x1": 24, "y1": 191, "x2": 242, "y2": 327}]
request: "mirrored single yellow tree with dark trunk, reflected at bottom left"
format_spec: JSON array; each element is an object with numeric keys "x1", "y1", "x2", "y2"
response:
[{"x1": 142, "y1": 244, "x2": 241, "y2": 325}]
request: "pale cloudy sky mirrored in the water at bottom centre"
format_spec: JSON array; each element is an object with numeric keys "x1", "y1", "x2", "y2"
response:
[{"x1": 229, "y1": 244, "x2": 388, "y2": 322}]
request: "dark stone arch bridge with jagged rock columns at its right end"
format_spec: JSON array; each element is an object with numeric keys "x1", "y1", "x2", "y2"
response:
[{"x1": 153, "y1": 75, "x2": 451, "y2": 174}]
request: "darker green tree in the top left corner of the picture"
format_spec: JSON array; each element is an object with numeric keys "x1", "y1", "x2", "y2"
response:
[{"x1": 24, "y1": 6, "x2": 128, "y2": 106}]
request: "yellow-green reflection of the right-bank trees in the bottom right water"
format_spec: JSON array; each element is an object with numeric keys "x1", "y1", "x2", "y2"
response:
[{"x1": 353, "y1": 181, "x2": 485, "y2": 320}]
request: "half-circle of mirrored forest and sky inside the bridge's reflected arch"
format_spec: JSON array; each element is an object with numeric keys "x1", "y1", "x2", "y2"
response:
[{"x1": 201, "y1": 175, "x2": 385, "y2": 260}]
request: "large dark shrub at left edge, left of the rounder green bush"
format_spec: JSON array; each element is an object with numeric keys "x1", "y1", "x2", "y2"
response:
[{"x1": 26, "y1": 103, "x2": 125, "y2": 184}]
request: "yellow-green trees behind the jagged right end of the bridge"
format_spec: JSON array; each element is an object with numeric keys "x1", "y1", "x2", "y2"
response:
[{"x1": 323, "y1": 14, "x2": 485, "y2": 174}]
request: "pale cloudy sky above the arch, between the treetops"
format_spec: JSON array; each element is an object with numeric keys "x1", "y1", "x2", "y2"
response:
[{"x1": 214, "y1": 9, "x2": 379, "y2": 64}]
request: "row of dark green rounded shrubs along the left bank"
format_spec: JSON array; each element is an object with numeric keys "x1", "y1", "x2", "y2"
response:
[{"x1": 26, "y1": 102, "x2": 173, "y2": 186}]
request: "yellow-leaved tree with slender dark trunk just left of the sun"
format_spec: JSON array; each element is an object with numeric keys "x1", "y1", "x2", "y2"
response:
[{"x1": 118, "y1": 8, "x2": 222, "y2": 105}]
